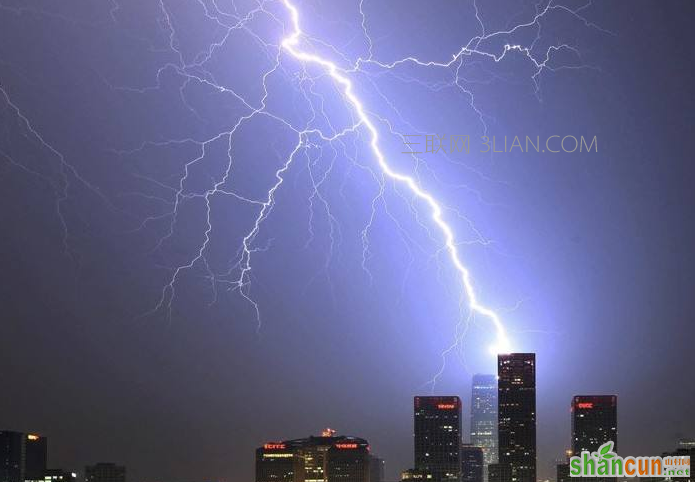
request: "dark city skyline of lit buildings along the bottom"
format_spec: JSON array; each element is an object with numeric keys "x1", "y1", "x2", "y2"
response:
[{"x1": 0, "y1": 353, "x2": 695, "y2": 482}]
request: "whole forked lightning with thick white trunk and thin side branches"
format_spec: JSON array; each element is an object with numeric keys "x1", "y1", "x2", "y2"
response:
[{"x1": 0, "y1": 0, "x2": 610, "y2": 389}]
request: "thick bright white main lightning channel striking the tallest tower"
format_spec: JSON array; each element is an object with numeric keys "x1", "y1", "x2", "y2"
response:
[{"x1": 282, "y1": 0, "x2": 511, "y2": 355}]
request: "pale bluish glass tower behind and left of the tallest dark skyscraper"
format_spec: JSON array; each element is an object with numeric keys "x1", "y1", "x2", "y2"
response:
[{"x1": 471, "y1": 375, "x2": 497, "y2": 472}]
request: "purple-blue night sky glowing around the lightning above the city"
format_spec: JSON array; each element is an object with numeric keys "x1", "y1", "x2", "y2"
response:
[{"x1": 0, "y1": 0, "x2": 695, "y2": 482}]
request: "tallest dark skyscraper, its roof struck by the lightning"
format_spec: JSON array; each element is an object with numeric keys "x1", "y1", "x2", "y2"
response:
[{"x1": 497, "y1": 353, "x2": 536, "y2": 482}]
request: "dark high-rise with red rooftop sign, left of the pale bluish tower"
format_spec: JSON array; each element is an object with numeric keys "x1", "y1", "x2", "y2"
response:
[{"x1": 414, "y1": 396, "x2": 461, "y2": 482}]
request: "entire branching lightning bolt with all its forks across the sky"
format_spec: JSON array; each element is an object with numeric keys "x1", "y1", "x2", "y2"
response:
[{"x1": 0, "y1": 0, "x2": 610, "y2": 388}]
